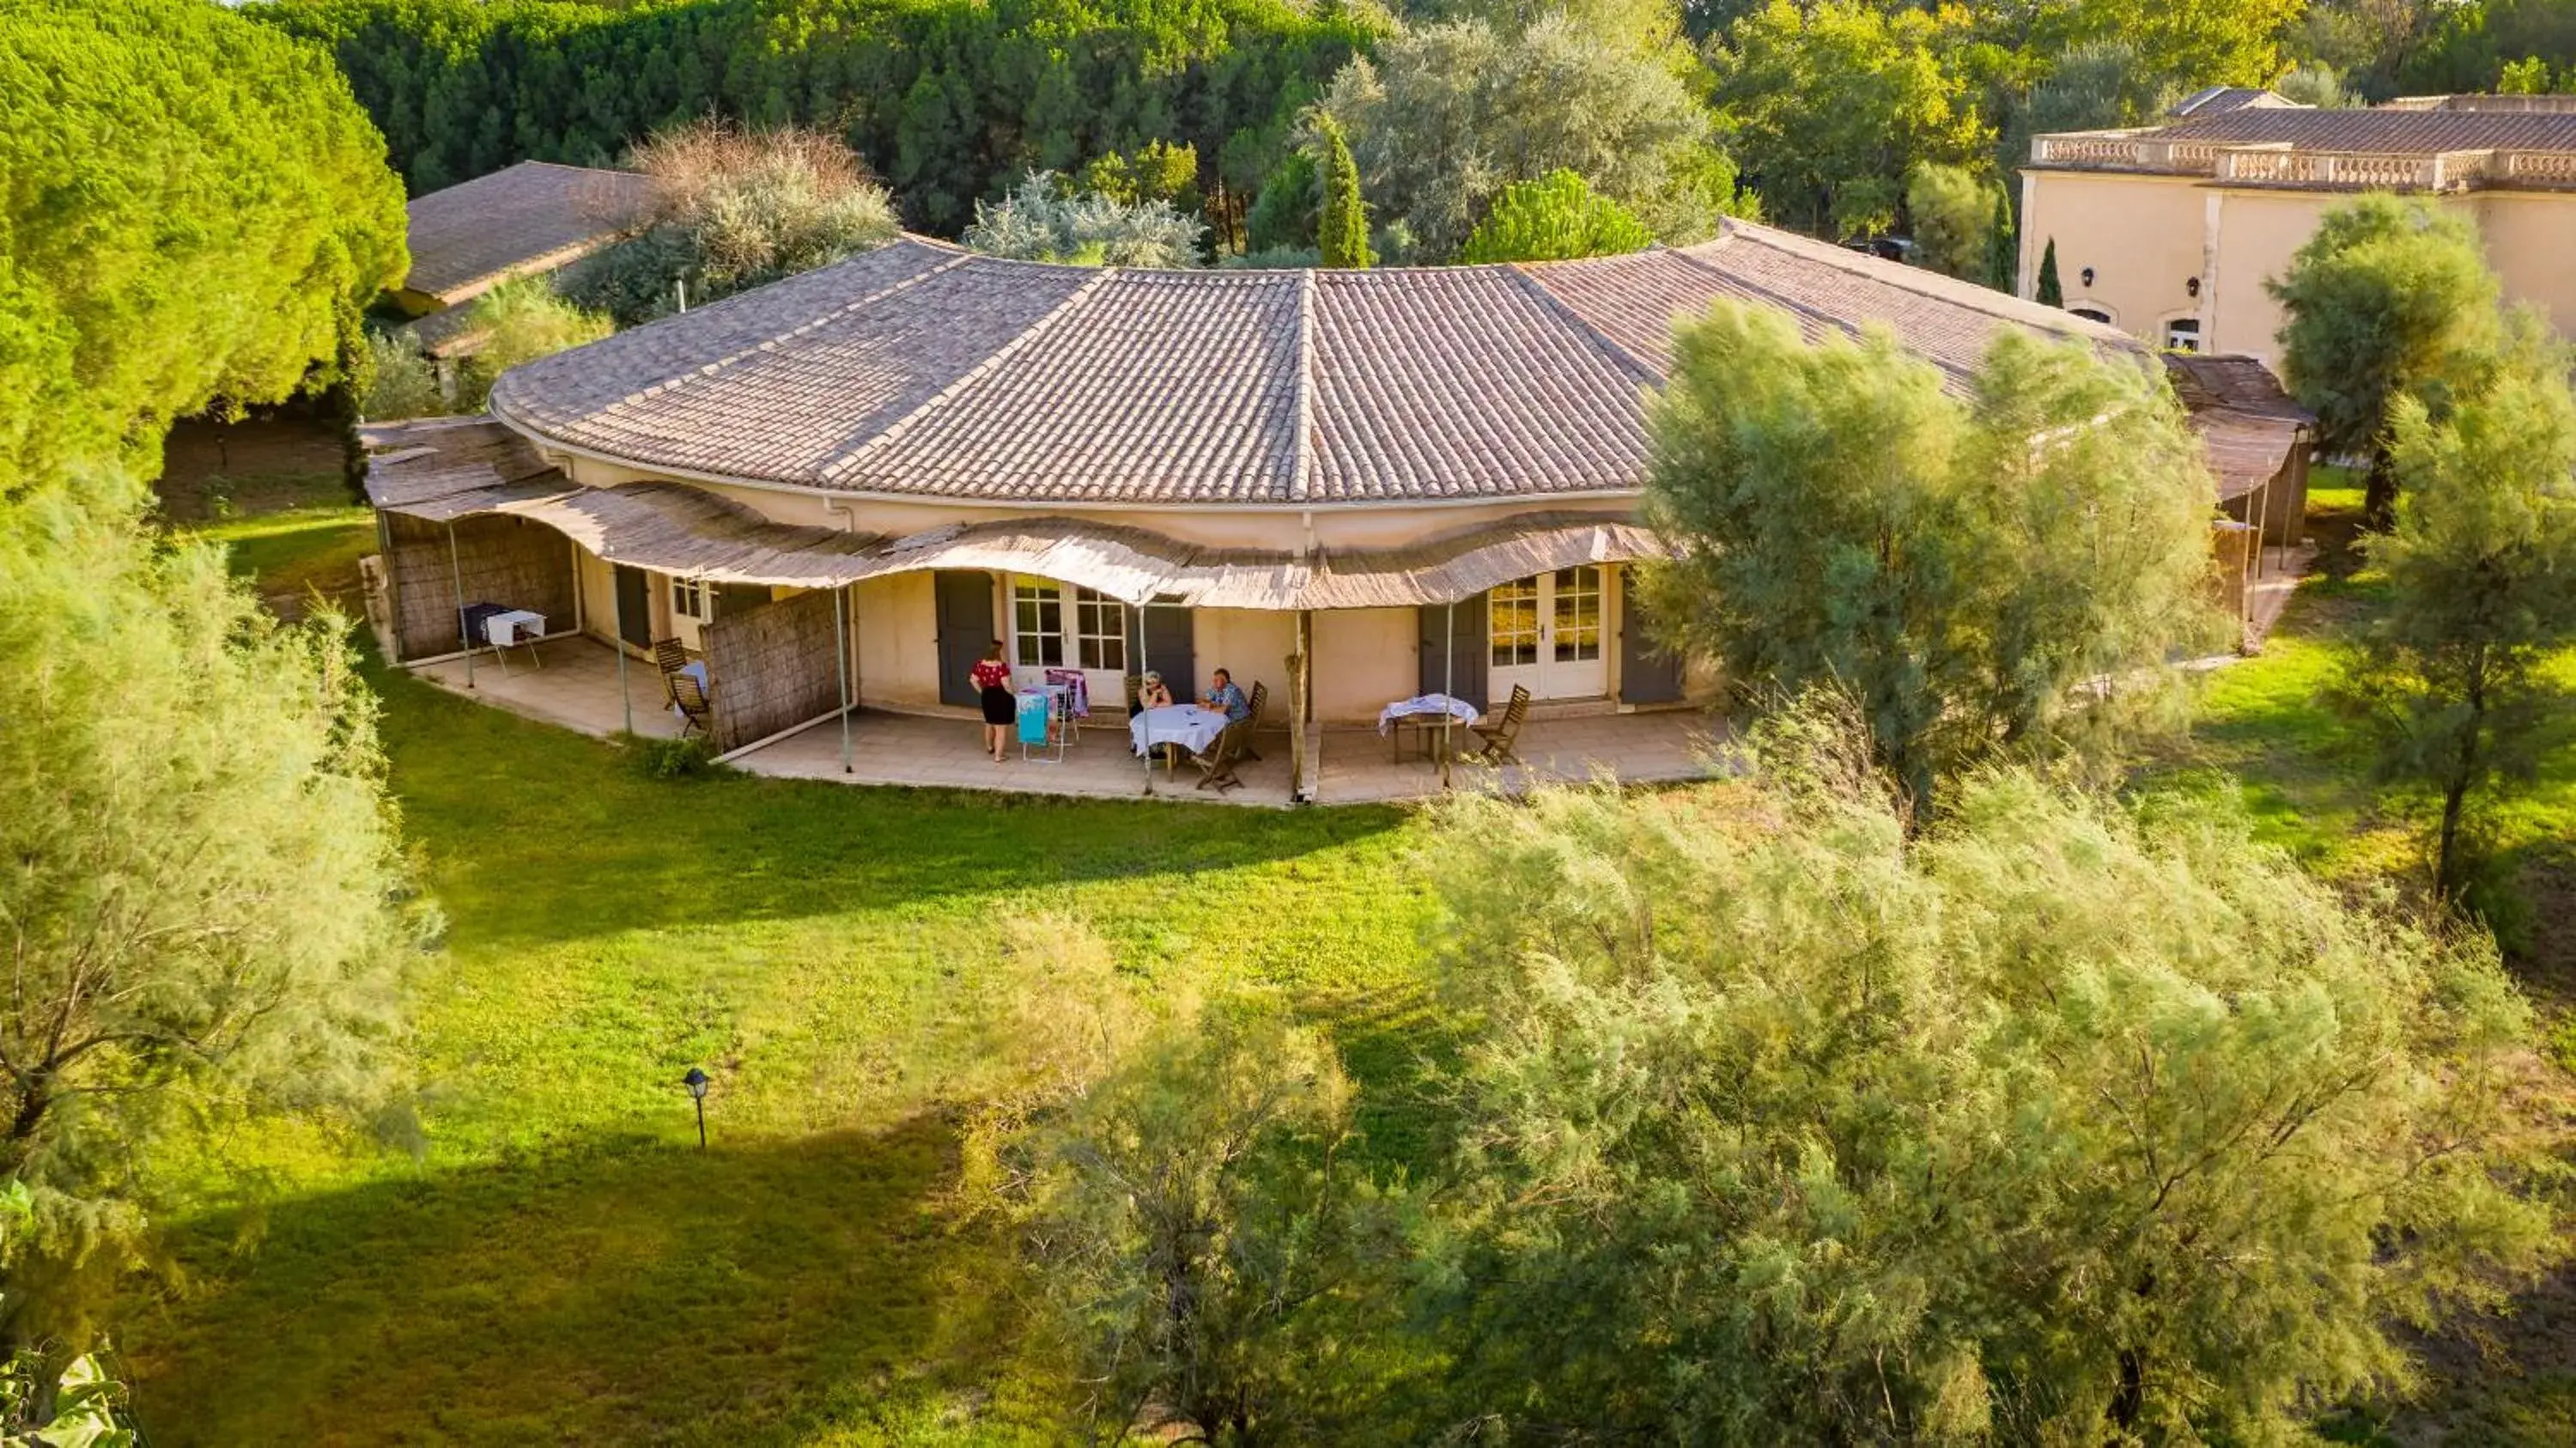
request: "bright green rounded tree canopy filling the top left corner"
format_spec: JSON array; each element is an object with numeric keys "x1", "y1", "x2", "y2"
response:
[{"x1": 0, "y1": 0, "x2": 410, "y2": 479}]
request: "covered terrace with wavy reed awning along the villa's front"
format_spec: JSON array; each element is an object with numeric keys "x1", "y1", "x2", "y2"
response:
[{"x1": 368, "y1": 420, "x2": 1708, "y2": 804}]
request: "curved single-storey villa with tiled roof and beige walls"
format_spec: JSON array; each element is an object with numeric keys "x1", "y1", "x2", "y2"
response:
[{"x1": 371, "y1": 222, "x2": 2306, "y2": 794}]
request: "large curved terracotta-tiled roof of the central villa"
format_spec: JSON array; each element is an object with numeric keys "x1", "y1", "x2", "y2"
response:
[{"x1": 492, "y1": 222, "x2": 2143, "y2": 505}]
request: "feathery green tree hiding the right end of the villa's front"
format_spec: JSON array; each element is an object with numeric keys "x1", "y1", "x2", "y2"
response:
[{"x1": 1646, "y1": 304, "x2": 2215, "y2": 806}]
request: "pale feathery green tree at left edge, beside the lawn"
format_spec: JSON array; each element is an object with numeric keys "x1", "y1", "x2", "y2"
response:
[{"x1": 0, "y1": 487, "x2": 412, "y2": 1342}]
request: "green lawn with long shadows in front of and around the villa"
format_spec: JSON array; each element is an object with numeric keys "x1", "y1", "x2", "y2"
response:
[{"x1": 126, "y1": 446, "x2": 2576, "y2": 1448}]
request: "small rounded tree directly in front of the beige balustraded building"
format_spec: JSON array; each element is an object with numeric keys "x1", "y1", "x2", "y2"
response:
[{"x1": 2264, "y1": 193, "x2": 2499, "y2": 531}]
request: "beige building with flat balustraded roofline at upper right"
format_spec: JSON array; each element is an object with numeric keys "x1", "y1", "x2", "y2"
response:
[{"x1": 2020, "y1": 90, "x2": 2576, "y2": 361}]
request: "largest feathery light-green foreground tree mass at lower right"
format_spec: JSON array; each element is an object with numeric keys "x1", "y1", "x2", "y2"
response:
[{"x1": 1419, "y1": 709, "x2": 2555, "y2": 1445}]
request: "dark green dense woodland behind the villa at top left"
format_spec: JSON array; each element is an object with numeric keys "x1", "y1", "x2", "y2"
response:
[{"x1": 255, "y1": 0, "x2": 1383, "y2": 232}]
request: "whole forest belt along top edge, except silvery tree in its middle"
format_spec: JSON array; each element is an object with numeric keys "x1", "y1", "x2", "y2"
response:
[{"x1": 247, "y1": 0, "x2": 2576, "y2": 247}]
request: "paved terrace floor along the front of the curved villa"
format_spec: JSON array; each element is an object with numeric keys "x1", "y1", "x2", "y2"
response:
[{"x1": 412, "y1": 636, "x2": 1718, "y2": 806}]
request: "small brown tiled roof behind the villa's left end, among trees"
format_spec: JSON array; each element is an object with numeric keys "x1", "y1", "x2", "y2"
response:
[{"x1": 402, "y1": 160, "x2": 652, "y2": 307}]
